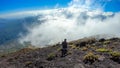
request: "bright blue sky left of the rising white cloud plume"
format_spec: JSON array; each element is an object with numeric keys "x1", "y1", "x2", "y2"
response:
[{"x1": 0, "y1": 0, "x2": 70, "y2": 13}]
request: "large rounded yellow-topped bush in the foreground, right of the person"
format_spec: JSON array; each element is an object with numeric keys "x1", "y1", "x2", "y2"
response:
[{"x1": 83, "y1": 52, "x2": 99, "y2": 64}]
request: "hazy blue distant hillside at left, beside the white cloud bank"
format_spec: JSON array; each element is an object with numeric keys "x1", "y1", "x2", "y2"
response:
[{"x1": 0, "y1": 16, "x2": 38, "y2": 45}]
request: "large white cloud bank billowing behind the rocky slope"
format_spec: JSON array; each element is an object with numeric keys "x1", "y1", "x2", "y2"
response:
[{"x1": 19, "y1": 0, "x2": 120, "y2": 47}]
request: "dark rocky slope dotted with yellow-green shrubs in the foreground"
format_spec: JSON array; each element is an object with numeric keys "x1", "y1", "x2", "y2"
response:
[{"x1": 0, "y1": 38, "x2": 120, "y2": 68}]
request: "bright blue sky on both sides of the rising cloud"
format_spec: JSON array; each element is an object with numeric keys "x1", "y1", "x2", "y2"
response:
[{"x1": 0, "y1": 0, "x2": 120, "y2": 14}]
